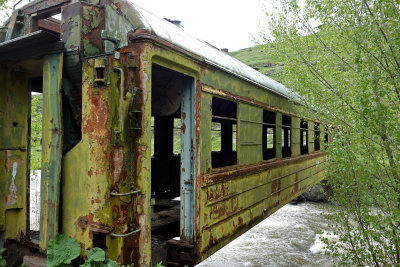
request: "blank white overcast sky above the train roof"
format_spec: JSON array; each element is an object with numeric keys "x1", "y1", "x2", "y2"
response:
[{"x1": 0, "y1": 0, "x2": 265, "y2": 51}]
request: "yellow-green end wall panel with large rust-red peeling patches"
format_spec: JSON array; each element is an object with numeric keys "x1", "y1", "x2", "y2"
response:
[{"x1": 62, "y1": 59, "x2": 117, "y2": 255}]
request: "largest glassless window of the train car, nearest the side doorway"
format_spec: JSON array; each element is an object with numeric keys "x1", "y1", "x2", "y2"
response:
[{"x1": 211, "y1": 97, "x2": 237, "y2": 168}]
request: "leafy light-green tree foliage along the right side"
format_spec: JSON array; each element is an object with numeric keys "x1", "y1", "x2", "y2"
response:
[{"x1": 264, "y1": 0, "x2": 400, "y2": 266}]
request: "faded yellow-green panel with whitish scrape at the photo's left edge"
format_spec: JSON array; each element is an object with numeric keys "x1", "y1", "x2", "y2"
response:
[{"x1": 0, "y1": 65, "x2": 29, "y2": 241}]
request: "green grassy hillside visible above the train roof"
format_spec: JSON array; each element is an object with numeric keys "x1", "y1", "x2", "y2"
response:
[{"x1": 229, "y1": 45, "x2": 281, "y2": 79}]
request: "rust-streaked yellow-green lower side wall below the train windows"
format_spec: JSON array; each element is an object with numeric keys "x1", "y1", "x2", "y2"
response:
[{"x1": 200, "y1": 153, "x2": 325, "y2": 259}]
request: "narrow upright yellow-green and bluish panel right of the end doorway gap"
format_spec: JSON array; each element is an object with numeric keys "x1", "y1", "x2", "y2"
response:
[{"x1": 40, "y1": 54, "x2": 63, "y2": 250}]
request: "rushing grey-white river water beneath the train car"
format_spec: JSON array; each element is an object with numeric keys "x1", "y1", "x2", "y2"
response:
[{"x1": 197, "y1": 202, "x2": 334, "y2": 267}]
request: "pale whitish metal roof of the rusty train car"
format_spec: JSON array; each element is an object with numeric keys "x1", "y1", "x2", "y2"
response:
[{"x1": 127, "y1": 2, "x2": 290, "y2": 98}]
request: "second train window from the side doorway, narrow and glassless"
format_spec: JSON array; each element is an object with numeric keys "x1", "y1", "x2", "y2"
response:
[{"x1": 263, "y1": 110, "x2": 276, "y2": 160}]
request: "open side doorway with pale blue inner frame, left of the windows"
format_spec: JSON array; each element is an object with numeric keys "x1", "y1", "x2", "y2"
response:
[{"x1": 151, "y1": 64, "x2": 194, "y2": 264}]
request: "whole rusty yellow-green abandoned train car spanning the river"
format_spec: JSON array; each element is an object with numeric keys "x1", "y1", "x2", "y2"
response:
[{"x1": 0, "y1": 0, "x2": 326, "y2": 266}]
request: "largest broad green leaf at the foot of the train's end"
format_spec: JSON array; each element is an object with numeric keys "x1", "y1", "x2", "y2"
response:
[{"x1": 47, "y1": 234, "x2": 81, "y2": 267}]
